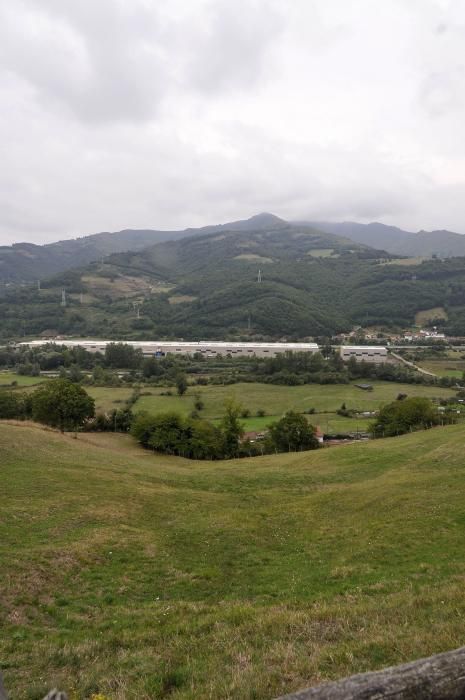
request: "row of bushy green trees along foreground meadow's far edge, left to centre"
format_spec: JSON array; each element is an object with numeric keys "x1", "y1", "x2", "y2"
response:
[{"x1": 0, "y1": 379, "x2": 319, "y2": 459}]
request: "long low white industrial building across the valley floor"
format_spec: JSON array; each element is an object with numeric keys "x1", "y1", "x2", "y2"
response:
[{"x1": 20, "y1": 339, "x2": 319, "y2": 357}]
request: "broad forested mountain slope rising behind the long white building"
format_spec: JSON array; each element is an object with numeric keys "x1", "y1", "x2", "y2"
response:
[{"x1": 4, "y1": 219, "x2": 465, "y2": 339}]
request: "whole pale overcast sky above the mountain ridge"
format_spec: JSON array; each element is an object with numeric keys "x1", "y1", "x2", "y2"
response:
[{"x1": 0, "y1": 0, "x2": 465, "y2": 243}]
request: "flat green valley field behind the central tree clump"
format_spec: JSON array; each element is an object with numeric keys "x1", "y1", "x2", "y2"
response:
[{"x1": 135, "y1": 382, "x2": 454, "y2": 430}]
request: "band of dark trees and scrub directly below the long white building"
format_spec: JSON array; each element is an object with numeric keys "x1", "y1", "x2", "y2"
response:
[{"x1": 0, "y1": 342, "x2": 456, "y2": 388}]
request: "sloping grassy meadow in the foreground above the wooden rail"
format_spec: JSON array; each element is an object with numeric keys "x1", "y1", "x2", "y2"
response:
[{"x1": 0, "y1": 423, "x2": 465, "y2": 700}]
